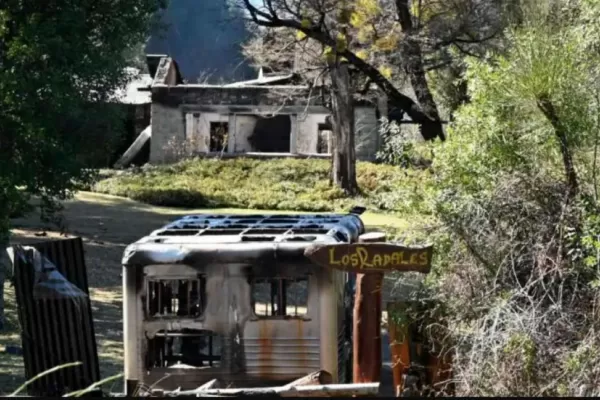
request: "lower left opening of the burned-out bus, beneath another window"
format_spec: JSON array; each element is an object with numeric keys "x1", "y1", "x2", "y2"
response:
[{"x1": 146, "y1": 329, "x2": 223, "y2": 370}]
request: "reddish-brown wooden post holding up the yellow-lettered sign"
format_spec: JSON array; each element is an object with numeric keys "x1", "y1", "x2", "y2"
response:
[{"x1": 352, "y1": 232, "x2": 385, "y2": 383}]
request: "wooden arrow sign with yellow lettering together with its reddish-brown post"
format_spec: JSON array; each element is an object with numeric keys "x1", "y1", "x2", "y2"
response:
[{"x1": 304, "y1": 232, "x2": 433, "y2": 390}]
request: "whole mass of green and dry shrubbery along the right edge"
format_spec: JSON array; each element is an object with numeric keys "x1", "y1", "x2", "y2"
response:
[{"x1": 392, "y1": 0, "x2": 600, "y2": 396}]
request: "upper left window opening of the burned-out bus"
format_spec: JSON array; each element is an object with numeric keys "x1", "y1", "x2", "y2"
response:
[{"x1": 145, "y1": 275, "x2": 206, "y2": 318}]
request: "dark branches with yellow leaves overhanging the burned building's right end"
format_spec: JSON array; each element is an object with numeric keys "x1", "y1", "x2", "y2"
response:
[{"x1": 241, "y1": 0, "x2": 507, "y2": 139}]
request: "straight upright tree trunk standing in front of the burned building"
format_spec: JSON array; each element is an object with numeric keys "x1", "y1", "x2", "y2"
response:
[{"x1": 330, "y1": 61, "x2": 358, "y2": 195}]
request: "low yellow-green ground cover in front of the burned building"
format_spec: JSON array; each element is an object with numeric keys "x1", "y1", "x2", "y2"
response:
[{"x1": 93, "y1": 158, "x2": 428, "y2": 214}]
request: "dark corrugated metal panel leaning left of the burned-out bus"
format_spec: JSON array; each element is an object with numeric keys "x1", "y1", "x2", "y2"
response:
[{"x1": 14, "y1": 238, "x2": 100, "y2": 396}]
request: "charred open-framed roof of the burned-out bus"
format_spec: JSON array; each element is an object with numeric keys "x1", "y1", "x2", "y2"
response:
[{"x1": 123, "y1": 213, "x2": 365, "y2": 266}]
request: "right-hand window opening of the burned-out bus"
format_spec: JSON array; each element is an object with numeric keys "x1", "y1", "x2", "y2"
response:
[{"x1": 252, "y1": 278, "x2": 308, "y2": 318}]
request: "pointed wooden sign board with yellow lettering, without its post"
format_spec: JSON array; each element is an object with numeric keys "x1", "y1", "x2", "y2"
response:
[{"x1": 304, "y1": 243, "x2": 433, "y2": 273}]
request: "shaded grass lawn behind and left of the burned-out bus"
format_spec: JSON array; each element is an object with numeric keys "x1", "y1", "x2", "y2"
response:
[{"x1": 0, "y1": 192, "x2": 408, "y2": 393}]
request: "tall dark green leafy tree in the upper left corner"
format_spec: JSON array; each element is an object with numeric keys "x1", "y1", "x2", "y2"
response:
[{"x1": 0, "y1": 0, "x2": 165, "y2": 324}]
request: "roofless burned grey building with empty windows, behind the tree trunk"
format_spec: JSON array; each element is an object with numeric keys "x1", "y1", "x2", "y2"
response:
[{"x1": 119, "y1": 55, "x2": 380, "y2": 166}]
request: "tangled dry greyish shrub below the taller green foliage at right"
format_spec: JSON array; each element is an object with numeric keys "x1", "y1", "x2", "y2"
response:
[{"x1": 422, "y1": 175, "x2": 600, "y2": 396}]
